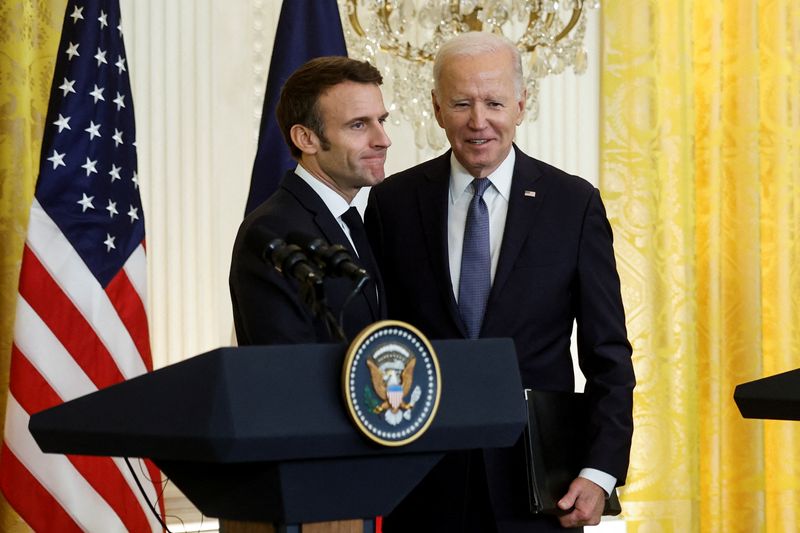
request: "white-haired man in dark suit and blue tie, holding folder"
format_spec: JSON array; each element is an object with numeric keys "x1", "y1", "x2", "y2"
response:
[{"x1": 367, "y1": 33, "x2": 635, "y2": 533}]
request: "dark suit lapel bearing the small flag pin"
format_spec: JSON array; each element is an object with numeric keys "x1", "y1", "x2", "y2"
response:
[{"x1": 482, "y1": 145, "x2": 547, "y2": 331}]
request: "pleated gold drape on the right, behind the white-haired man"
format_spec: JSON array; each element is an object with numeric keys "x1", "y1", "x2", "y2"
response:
[{"x1": 601, "y1": 0, "x2": 800, "y2": 533}]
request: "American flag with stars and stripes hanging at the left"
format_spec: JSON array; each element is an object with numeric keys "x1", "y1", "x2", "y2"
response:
[{"x1": 0, "y1": 0, "x2": 163, "y2": 533}]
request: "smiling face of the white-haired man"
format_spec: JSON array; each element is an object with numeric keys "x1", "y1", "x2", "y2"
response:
[{"x1": 433, "y1": 50, "x2": 525, "y2": 178}]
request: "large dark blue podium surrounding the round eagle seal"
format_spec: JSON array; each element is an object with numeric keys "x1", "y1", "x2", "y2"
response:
[{"x1": 29, "y1": 339, "x2": 526, "y2": 525}]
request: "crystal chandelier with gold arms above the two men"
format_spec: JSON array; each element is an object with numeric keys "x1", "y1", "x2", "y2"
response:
[{"x1": 338, "y1": 0, "x2": 599, "y2": 150}]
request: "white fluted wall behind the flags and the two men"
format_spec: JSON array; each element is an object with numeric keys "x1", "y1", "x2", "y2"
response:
[{"x1": 121, "y1": 0, "x2": 600, "y2": 367}]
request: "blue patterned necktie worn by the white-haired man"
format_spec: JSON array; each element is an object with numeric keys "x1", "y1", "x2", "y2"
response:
[{"x1": 458, "y1": 178, "x2": 492, "y2": 339}]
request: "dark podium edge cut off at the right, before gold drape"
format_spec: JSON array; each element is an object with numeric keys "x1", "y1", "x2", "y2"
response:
[{"x1": 733, "y1": 368, "x2": 800, "y2": 420}]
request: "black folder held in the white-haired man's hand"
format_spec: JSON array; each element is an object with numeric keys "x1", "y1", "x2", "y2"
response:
[{"x1": 525, "y1": 389, "x2": 622, "y2": 515}]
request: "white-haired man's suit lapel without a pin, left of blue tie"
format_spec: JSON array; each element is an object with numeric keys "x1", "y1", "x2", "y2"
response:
[{"x1": 417, "y1": 154, "x2": 467, "y2": 336}]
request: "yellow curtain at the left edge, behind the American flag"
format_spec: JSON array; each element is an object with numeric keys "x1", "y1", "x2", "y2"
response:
[{"x1": 0, "y1": 0, "x2": 67, "y2": 533}]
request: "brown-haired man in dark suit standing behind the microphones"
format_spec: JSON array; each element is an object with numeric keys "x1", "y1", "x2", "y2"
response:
[{"x1": 230, "y1": 57, "x2": 391, "y2": 345}]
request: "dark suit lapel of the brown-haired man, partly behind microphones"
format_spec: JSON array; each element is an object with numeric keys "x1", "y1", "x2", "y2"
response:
[{"x1": 281, "y1": 171, "x2": 386, "y2": 321}]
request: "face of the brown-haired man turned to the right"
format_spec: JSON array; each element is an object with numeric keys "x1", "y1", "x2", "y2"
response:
[{"x1": 316, "y1": 81, "x2": 392, "y2": 198}]
